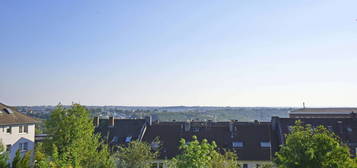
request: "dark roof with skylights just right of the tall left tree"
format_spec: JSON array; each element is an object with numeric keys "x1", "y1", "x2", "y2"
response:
[{"x1": 95, "y1": 119, "x2": 146, "y2": 147}]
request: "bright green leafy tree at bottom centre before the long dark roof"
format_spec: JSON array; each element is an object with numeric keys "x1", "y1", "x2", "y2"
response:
[{"x1": 170, "y1": 136, "x2": 239, "y2": 168}]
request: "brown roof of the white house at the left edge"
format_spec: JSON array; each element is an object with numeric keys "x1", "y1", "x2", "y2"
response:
[{"x1": 0, "y1": 103, "x2": 39, "y2": 125}]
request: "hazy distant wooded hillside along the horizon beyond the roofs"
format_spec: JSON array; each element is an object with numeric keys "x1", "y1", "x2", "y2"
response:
[{"x1": 17, "y1": 106, "x2": 294, "y2": 121}]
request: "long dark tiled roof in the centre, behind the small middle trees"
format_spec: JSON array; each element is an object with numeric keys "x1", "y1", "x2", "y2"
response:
[{"x1": 143, "y1": 122, "x2": 271, "y2": 160}]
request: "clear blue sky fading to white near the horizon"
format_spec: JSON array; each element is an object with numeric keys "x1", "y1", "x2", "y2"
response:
[{"x1": 0, "y1": 0, "x2": 357, "y2": 106}]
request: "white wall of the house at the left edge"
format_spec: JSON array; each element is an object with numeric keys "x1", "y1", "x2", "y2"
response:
[{"x1": 0, "y1": 124, "x2": 35, "y2": 162}]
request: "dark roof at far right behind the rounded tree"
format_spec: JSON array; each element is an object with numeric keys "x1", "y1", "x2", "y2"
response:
[{"x1": 272, "y1": 117, "x2": 357, "y2": 157}]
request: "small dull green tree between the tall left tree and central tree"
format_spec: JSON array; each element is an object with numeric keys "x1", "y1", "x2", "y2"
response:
[{"x1": 116, "y1": 141, "x2": 158, "y2": 168}]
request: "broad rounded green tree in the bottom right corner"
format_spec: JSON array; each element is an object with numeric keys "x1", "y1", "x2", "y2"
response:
[{"x1": 275, "y1": 121, "x2": 357, "y2": 168}]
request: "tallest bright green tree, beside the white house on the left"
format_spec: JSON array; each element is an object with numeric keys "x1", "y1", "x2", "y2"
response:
[{"x1": 42, "y1": 104, "x2": 115, "y2": 168}]
